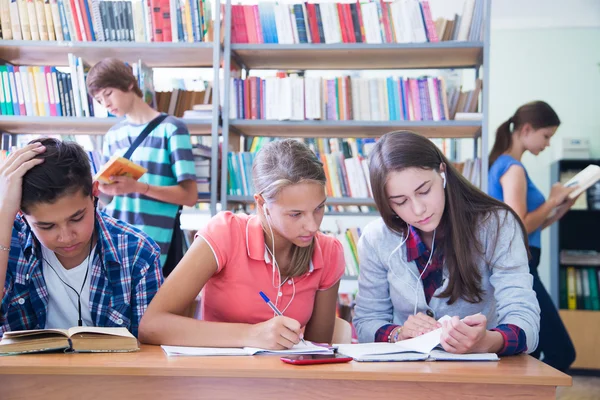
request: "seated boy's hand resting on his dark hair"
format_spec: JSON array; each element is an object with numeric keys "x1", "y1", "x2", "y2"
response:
[{"x1": 0, "y1": 143, "x2": 46, "y2": 219}]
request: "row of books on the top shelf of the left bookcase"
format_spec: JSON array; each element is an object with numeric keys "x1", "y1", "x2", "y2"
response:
[{"x1": 0, "y1": 0, "x2": 212, "y2": 42}]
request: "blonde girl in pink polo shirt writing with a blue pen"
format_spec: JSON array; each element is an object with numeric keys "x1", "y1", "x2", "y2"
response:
[{"x1": 139, "y1": 139, "x2": 345, "y2": 349}]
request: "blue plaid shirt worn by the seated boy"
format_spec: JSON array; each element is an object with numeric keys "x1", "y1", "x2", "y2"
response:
[{"x1": 0, "y1": 211, "x2": 163, "y2": 337}]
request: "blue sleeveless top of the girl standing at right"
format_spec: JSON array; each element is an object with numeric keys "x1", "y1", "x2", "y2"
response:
[{"x1": 488, "y1": 154, "x2": 546, "y2": 248}]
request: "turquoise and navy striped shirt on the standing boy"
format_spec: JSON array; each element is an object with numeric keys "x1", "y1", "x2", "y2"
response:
[{"x1": 103, "y1": 116, "x2": 196, "y2": 265}]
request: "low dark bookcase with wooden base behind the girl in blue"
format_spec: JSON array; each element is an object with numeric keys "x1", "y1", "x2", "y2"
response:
[{"x1": 542, "y1": 159, "x2": 600, "y2": 370}]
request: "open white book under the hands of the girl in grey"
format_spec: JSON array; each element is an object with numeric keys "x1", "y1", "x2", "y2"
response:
[{"x1": 337, "y1": 315, "x2": 498, "y2": 361}]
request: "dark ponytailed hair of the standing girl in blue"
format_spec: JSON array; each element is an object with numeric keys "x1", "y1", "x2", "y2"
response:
[{"x1": 489, "y1": 101, "x2": 560, "y2": 167}]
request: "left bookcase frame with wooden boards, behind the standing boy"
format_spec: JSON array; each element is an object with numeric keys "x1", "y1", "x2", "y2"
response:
[{"x1": 0, "y1": 3, "x2": 222, "y2": 214}]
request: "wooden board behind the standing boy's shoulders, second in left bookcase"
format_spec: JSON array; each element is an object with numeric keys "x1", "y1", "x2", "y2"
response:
[{"x1": 0, "y1": 115, "x2": 211, "y2": 136}]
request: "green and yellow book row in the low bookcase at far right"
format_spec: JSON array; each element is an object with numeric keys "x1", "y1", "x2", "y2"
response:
[{"x1": 559, "y1": 266, "x2": 600, "y2": 311}]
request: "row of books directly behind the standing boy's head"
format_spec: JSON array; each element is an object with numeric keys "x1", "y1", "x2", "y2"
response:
[{"x1": 0, "y1": 53, "x2": 156, "y2": 117}]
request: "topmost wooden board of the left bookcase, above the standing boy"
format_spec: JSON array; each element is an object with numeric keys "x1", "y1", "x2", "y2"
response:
[{"x1": 0, "y1": 40, "x2": 213, "y2": 67}]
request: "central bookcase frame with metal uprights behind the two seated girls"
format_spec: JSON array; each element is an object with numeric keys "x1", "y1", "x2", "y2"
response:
[{"x1": 220, "y1": 0, "x2": 491, "y2": 209}]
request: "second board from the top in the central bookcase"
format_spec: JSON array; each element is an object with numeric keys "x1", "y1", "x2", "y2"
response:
[{"x1": 230, "y1": 119, "x2": 481, "y2": 138}]
